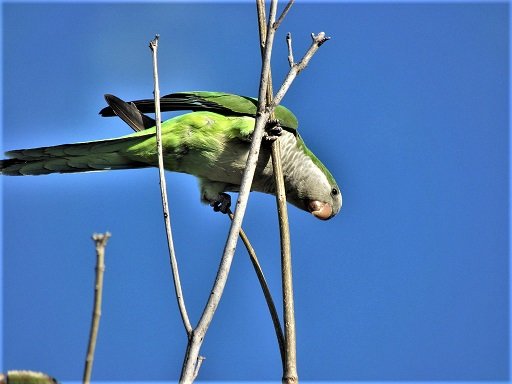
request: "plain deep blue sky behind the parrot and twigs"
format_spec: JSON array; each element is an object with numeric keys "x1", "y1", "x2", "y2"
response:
[{"x1": 1, "y1": 1, "x2": 510, "y2": 382}]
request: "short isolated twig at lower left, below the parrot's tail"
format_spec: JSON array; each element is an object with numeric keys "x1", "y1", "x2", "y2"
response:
[{"x1": 83, "y1": 232, "x2": 111, "y2": 384}]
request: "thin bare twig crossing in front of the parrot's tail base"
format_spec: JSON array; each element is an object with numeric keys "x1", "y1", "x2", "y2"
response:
[{"x1": 149, "y1": 35, "x2": 192, "y2": 338}]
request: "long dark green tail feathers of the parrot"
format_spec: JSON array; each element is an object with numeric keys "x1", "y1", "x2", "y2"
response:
[{"x1": 0, "y1": 137, "x2": 150, "y2": 176}]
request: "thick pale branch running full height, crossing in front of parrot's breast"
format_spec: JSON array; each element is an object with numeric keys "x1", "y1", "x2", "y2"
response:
[{"x1": 180, "y1": 0, "x2": 277, "y2": 383}]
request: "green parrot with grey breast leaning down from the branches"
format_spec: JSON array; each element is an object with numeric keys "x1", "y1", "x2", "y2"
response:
[{"x1": 0, "y1": 92, "x2": 342, "y2": 220}]
